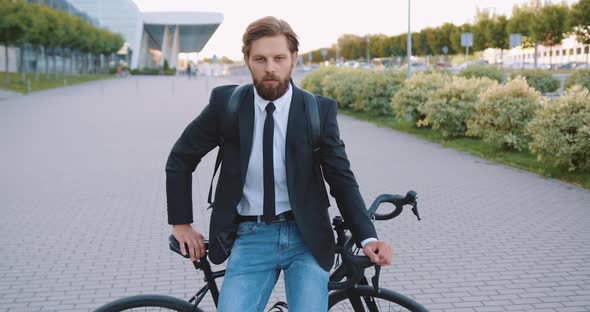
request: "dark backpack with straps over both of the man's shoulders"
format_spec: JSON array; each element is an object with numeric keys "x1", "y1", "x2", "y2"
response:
[{"x1": 207, "y1": 83, "x2": 320, "y2": 208}]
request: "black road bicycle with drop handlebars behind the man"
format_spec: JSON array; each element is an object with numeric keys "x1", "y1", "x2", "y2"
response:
[{"x1": 95, "y1": 191, "x2": 428, "y2": 312}]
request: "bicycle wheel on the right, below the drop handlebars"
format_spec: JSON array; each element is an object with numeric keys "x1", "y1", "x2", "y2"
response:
[{"x1": 328, "y1": 286, "x2": 428, "y2": 312}]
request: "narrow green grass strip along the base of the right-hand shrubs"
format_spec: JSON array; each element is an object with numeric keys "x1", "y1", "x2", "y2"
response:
[{"x1": 340, "y1": 109, "x2": 590, "y2": 189}]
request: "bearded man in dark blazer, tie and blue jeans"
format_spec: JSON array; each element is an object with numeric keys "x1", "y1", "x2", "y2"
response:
[{"x1": 166, "y1": 17, "x2": 392, "y2": 312}]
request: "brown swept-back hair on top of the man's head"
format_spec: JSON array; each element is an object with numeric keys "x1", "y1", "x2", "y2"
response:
[{"x1": 242, "y1": 16, "x2": 299, "y2": 57}]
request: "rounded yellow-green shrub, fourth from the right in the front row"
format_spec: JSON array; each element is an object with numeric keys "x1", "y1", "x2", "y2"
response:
[{"x1": 390, "y1": 72, "x2": 451, "y2": 122}]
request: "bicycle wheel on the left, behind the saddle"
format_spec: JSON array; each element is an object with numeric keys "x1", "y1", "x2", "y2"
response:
[{"x1": 94, "y1": 295, "x2": 203, "y2": 312}]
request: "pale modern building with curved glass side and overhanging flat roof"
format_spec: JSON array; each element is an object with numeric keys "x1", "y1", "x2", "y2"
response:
[{"x1": 69, "y1": 0, "x2": 223, "y2": 68}]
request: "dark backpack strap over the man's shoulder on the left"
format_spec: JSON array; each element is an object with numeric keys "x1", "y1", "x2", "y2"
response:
[{"x1": 207, "y1": 84, "x2": 252, "y2": 208}]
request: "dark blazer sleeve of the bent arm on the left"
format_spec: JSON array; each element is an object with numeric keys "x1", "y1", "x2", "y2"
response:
[{"x1": 166, "y1": 90, "x2": 220, "y2": 224}]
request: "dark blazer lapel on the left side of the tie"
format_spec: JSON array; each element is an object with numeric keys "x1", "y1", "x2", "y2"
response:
[{"x1": 238, "y1": 88, "x2": 254, "y2": 183}]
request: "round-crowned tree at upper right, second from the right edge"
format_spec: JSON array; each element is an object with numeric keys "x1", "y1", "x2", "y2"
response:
[{"x1": 532, "y1": 3, "x2": 569, "y2": 65}]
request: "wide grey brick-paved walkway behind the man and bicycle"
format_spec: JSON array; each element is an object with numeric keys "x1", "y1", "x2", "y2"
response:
[{"x1": 0, "y1": 77, "x2": 590, "y2": 312}]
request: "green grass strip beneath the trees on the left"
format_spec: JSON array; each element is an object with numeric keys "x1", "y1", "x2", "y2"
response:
[{"x1": 0, "y1": 72, "x2": 114, "y2": 94}]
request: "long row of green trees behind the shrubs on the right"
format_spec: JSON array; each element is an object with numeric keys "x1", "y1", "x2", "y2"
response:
[{"x1": 304, "y1": 0, "x2": 590, "y2": 64}]
